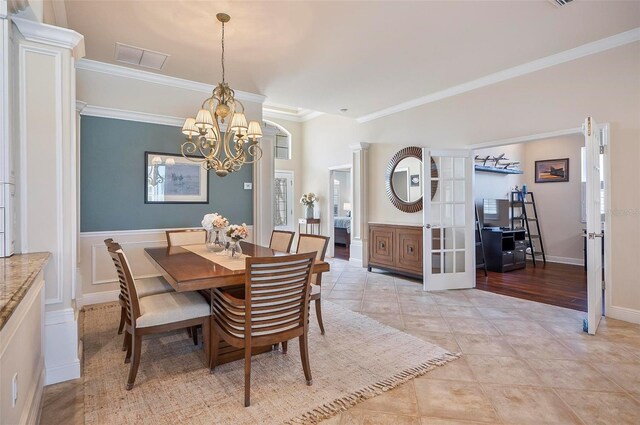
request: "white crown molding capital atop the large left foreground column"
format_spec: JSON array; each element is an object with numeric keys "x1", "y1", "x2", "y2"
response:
[{"x1": 11, "y1": 16, "x2": 84, "y2": 59}]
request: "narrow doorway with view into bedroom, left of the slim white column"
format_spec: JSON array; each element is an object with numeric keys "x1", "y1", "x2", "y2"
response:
[{"x1": 328, "y1": 165, "x2": 353, "y2": 261}]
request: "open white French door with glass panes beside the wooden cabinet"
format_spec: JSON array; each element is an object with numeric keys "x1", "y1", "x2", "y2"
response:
[{"x1": 422, "y1": 148, "x2": 475, "y2": 291}]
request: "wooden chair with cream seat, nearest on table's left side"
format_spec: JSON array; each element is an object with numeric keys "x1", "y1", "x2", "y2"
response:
[{"x1": 107, "y1": 243, "x2": 211, "y2": 390}]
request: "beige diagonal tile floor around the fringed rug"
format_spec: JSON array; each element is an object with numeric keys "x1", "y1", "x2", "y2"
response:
[{"x1": 42, "y1": 260, "x2": 640, "y2": 425}]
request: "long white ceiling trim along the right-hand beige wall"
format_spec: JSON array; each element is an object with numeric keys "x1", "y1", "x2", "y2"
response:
[{"x1": 356, "y1": 27, "x2": 640, "y2": 124}]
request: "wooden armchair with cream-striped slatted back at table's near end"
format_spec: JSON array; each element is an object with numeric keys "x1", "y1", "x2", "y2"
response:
[{"x1": 210, "y1": 253, "x2": 315, "y2": 407}]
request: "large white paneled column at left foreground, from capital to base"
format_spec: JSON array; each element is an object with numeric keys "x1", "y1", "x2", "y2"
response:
[{"x1": 12, "y1": 18, "x2": 84, "y2": 384}]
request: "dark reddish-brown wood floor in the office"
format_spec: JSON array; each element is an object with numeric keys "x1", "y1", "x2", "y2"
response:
[{"x1": 476, "y1": 262, "x2": 587, "y2": 311}]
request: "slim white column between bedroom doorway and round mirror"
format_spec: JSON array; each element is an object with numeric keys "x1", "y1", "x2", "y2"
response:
[{"x1": 349, "y1": 142, "x2": 369, "y2": 267}]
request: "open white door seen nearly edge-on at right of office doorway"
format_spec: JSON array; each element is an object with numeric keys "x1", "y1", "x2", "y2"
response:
[{"x1": 583, "y1": 117, "x2": 606, "y2": 335}]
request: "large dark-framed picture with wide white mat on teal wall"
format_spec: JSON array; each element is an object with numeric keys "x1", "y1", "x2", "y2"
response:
[{"x1": 144, "y1": 152, "x2": 209, "y2": 204}]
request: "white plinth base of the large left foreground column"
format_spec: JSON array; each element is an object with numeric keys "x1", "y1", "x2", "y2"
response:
[{"x1": 44, "y1": 308, "x2": 80, "y2": 385}]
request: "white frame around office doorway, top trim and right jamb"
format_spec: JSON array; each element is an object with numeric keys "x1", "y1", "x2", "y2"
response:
[{"x1": 470, "y1": 123, "x2": 614, "y2": 322}]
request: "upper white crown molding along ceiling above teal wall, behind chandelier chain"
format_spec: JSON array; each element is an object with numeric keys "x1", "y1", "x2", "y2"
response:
[{"x1": 76, "y1": 59, "x2": 266, "y2": 104}]
